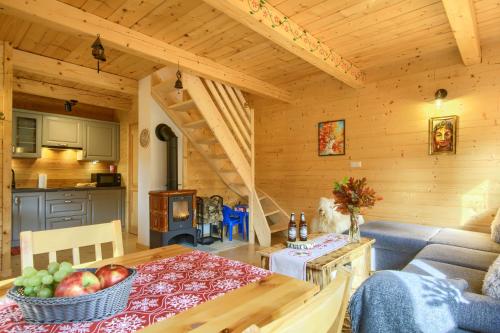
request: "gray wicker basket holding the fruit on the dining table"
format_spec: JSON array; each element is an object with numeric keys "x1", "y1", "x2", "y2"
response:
[{"x1": 7, "y1": 268, "x2": 137, "y2": 324}]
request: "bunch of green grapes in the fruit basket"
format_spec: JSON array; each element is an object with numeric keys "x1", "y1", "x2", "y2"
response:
[{"x1": 14, "y1": 261, "x2": 75, "y2": 298}]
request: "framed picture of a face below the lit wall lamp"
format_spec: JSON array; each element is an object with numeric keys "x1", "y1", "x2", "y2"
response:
[{"x1": 429, "y1": 116, "x2": 458, "y2": 155}]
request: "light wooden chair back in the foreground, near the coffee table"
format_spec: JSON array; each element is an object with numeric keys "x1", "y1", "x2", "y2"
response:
[{"x1": 243, "y1": 268, "x2": 352, "y2": 333}]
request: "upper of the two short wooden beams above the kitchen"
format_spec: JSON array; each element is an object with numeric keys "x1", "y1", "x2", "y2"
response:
[{"x1": 13, "y1": 50, "x2": 138, "y2": 96}]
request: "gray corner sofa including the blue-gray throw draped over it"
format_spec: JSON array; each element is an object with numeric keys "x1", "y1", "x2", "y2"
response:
[{"x1": 350, "y1": 222, "x2": 500, "y2": 333}]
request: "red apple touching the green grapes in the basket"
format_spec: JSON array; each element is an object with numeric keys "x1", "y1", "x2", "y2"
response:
[{"x1": 54, "y1": 271, "x2": 101, "y2": 297}]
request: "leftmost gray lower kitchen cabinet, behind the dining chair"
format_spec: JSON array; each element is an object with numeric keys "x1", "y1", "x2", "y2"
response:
[{"x1": 12, "y1": 192, "x2": 45, "y2": 246}]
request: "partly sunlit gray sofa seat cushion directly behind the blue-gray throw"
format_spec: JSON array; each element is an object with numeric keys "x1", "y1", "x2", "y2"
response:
[{"x1": 403, "y1": 259, "x2": 486, "y2": 293}]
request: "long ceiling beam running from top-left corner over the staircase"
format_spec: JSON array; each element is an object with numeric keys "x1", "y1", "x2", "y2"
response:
[{"x1": 0, "y1": 0, "x2": 291, "y2": 101}]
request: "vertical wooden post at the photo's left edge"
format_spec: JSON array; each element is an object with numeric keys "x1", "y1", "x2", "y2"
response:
[{"x1": 0, "y1": 42, "x2": 13, "y2": 277}]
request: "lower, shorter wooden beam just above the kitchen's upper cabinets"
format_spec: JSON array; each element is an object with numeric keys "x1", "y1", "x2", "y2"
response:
[{"x1": 13, "y1": 76, "x2": 132, "y2": 111}]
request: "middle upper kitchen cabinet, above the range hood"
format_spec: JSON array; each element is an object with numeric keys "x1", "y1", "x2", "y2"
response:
[{"x1": 42, "y1": 115, "x2": 84, "y2": 148}]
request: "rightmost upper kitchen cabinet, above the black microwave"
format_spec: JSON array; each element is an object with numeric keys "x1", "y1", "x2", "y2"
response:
[{"x1": 78, "y1": 121, "x2": 119, "y2": 161}]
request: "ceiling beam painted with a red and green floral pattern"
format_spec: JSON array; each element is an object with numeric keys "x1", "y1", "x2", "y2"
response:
[{"x1": 203, "y1": 0, "x2": 365, "y2": 88}]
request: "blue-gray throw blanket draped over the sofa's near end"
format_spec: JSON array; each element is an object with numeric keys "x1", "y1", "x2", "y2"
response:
[{"x1": 349, "y1": 271, "x2": 467, "y2": 333}]
